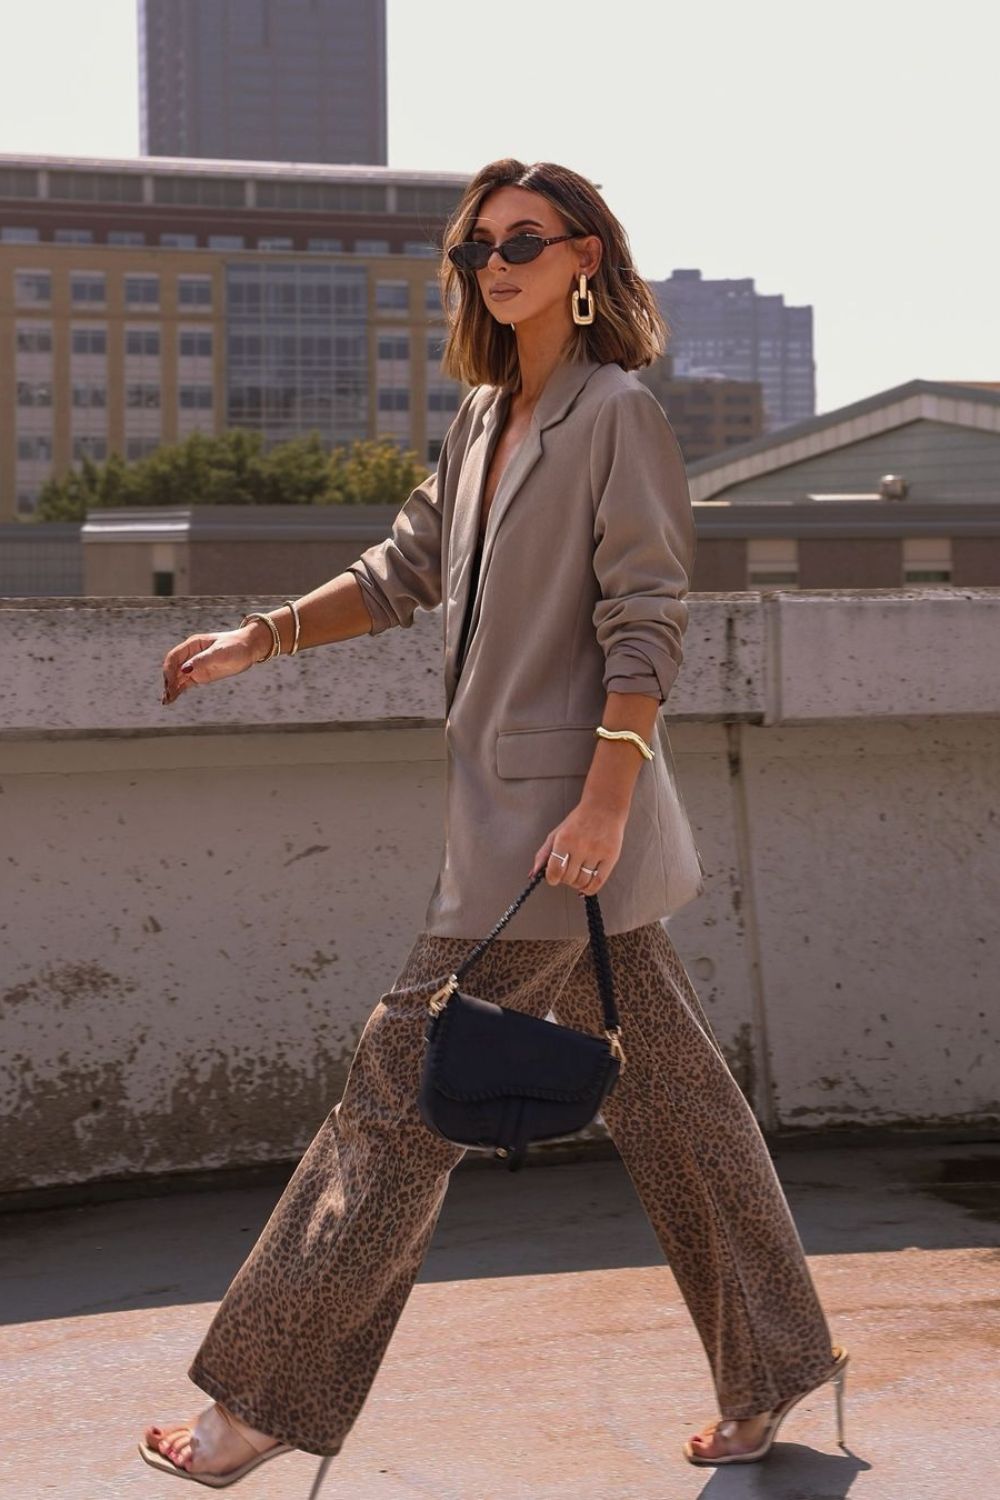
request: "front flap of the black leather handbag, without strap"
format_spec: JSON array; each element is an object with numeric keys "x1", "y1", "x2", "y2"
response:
[{"x1": 430, "y1": 992, "x2": 616, "y2": 1101}]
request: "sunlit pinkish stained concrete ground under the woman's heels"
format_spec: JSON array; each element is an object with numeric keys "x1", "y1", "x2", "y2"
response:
[{"x1": 0, "y1": 1142, "x2": 1000, "y2": 1500}]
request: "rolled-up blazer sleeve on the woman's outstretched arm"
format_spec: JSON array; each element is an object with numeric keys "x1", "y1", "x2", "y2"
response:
[{"x1": 346, "y1": 387, "x2": 478, "y2": 636}]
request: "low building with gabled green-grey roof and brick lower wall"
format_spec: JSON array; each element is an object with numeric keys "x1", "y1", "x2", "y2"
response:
[{"x1": 688, "y1": 380, "x2": 1000, "y2": 591}]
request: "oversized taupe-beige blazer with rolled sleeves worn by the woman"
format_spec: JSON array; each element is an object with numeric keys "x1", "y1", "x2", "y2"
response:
[{"x1": 351, "y1": 352, "x2": 705, "y2": 941}]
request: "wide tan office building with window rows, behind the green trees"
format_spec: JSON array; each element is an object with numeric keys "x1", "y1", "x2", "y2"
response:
[{"x1": 0, "y1": 156, "x2": 468, "y2": 522}]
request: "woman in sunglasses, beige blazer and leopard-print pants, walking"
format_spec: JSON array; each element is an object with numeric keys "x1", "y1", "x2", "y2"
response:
[{"x1": 141, "y1": 161, "x2": 847, "y2": 1493}]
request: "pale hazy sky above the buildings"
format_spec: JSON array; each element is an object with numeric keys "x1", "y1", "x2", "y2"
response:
[{"x1": 0, "y1": 0, "x2": 1000, "y2": 411}]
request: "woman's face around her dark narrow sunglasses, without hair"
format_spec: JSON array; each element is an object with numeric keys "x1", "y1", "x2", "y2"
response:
[{"x1": 469, "y1": 188, "x2": 601, "y2": 327}]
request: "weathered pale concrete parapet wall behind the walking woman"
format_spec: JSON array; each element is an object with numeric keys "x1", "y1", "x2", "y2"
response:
[{"x1": 0, "y1": 590, "x2": 1000, "y2": 1190}]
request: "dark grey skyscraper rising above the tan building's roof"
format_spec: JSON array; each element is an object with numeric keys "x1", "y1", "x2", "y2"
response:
[{"x1": 139, "y1": 0, "x2": 387, "y2": 165}]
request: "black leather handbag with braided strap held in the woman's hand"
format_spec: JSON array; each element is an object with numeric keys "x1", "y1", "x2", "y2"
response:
[{"x1": 418, "y1": 866, "x2": 625, "y2": 1172}]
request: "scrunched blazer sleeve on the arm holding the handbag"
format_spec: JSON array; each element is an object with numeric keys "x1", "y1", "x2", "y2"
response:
[{"x1": 591, "y1": 384, "x2": 697, "y2": 702}]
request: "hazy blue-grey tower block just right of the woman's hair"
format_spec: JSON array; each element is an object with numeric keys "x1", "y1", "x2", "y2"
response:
[{"x1": 649, "y1": 270, "x2": 816, "y2": 432}]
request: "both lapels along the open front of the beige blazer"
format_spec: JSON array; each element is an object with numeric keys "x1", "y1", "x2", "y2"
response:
[{"x1": 445, "y1": 360, "x2": 600, "y2": 701}]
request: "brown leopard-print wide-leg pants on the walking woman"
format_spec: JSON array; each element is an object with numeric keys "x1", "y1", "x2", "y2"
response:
[{"x1": 189, "y1": 923, "x2": 832, "y2": 1454}]
